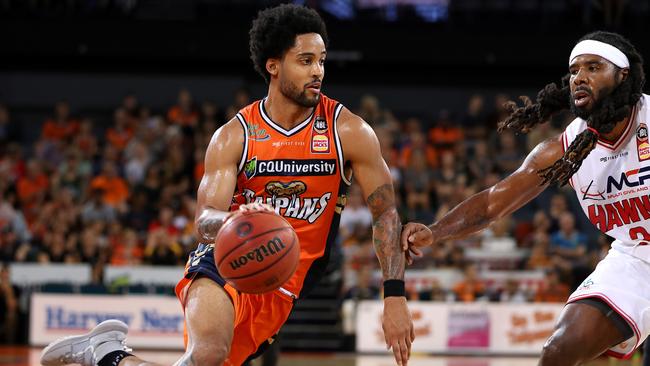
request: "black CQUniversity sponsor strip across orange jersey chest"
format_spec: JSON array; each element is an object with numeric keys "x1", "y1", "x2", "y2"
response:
[{"x1": 244, "y1": 157, "x2": 336, "y2": 179}]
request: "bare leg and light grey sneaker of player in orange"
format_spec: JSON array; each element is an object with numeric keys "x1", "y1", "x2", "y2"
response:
[{"x1": 41, "y1": 278, "x2": 235, "y2": 366}]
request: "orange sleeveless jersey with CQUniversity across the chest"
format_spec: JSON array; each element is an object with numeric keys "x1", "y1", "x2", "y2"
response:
[{"x1": 232, "y1": 94, "x2": 350, "y2": 296}]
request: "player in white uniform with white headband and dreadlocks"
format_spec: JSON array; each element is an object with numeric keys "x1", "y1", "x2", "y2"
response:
[{"x1": 402, "y1": 32, "x2": 650, "y2": 366}]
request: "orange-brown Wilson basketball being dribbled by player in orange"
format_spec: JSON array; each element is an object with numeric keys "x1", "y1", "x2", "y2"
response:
[{"x1": 214, "y1": 211, "x2": 300, "y2": 294}]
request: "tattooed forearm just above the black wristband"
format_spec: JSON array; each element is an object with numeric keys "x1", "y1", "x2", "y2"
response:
[{"x1": 366, "y1": 184, "x2": 406, "y2": 280}]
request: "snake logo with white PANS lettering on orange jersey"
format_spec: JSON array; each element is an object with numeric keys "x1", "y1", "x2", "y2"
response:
[{"x1": 242, "y1": 180, "x2": 332, "y2": 224}]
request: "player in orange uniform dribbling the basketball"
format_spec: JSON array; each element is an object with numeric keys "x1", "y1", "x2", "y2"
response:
[{"x1": 41, "y1": 5, "x2": 414, "y2": 366}]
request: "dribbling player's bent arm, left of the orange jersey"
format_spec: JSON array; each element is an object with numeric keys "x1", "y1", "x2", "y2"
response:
[{"x1": 195, "y1": 118, "x2": 244, "y2": 243}]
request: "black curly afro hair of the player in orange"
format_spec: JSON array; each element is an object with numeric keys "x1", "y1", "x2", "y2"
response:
[{"x1": 249, "y1": 4, "x2": 329, "y2": 83}]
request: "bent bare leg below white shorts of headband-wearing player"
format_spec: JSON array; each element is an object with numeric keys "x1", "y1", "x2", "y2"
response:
[{"x1": 539, "y1": 299, "x2": 632, "y2": 366}]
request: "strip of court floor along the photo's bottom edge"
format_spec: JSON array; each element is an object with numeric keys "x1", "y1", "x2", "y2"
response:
[{"x1": 0, "y1": 347, "x2": 641, "y2": 366}]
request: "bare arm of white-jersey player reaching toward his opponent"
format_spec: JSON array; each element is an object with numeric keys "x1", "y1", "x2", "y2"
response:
[{"x1": 401, "y1": 135, "x2": 564, "y2": 256}]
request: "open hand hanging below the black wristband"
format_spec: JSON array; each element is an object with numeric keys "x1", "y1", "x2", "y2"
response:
[{"x1": 381, "y1": 296, "x2": 415, "y2": 366}]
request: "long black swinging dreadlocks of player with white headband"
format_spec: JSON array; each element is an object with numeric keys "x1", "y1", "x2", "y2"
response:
[{"x1": 499, "y1": 32, "x2": 645, "y2": 186}]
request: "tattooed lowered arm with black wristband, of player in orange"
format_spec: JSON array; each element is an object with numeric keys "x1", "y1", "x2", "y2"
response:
[{"x1": 338, "y1": 108, "x2": 415, "y2": 365}]
